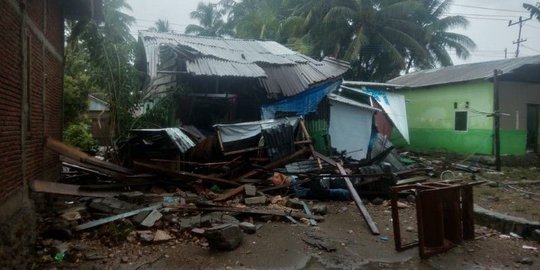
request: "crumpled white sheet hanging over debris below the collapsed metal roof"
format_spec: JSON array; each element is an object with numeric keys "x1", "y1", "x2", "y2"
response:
[{"x1": 214, "y1": 117, "x2": 300, "y2": 143}]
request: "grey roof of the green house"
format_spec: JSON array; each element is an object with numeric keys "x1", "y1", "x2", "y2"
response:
[{"x1": 388, "y1": 55, "x2": 540, "y2": 87}]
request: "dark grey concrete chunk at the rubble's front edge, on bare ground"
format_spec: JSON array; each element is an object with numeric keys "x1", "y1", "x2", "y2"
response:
[{"x1": 204, "y1": 224, "x2": 242, "y2": 250}]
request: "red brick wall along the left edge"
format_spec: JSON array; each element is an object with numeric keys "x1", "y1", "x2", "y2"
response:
[{"x1": 0, "y1": 0, "x2": 63, "y2": 202}]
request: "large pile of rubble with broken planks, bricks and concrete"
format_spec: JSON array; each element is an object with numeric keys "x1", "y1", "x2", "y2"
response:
[{"x1": 31, "y1": 118, "x2": 464, "y2": 261}]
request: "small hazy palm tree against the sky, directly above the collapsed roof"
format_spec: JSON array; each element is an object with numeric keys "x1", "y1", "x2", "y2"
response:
[{"x1": 185, "y1": 2, "x2": 232, "y2": 37}]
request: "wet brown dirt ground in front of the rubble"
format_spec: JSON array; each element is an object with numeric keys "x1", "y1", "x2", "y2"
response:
[{"x1": 34, "y1": 202, "x2": 540, "y2": 269}]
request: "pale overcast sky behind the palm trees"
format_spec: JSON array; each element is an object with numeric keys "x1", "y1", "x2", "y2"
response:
[{"x1": 127, "y1": 0, "x2": 540, "y2": 64}]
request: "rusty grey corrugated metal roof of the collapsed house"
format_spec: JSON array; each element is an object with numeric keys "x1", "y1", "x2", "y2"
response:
[{"x1": 139, "y1": 31, "x2": 350, "y2": 96}]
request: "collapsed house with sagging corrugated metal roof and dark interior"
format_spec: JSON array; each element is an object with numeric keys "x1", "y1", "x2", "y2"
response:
[{"x1": 138, "y1": 31, "x2": 349, "y2": 128}]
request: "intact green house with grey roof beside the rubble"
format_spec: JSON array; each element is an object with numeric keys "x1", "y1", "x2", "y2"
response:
[{"x1": 388, "y1": 55, "x2": 540, "y2": 155}]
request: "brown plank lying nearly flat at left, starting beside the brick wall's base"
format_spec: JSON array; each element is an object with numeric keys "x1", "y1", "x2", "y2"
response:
[{"x1": 30, "y1": 180, "x2": 120, "y2": 197}]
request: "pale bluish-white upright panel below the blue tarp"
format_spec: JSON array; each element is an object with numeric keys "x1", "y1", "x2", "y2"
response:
[{"x1": 329, "y1": 95, "x2": 376, "y2": 160}]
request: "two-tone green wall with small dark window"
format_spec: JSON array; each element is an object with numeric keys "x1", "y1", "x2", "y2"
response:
[{"x1": 395, "y1": 80, "x2": 496, "y2": 154}]
